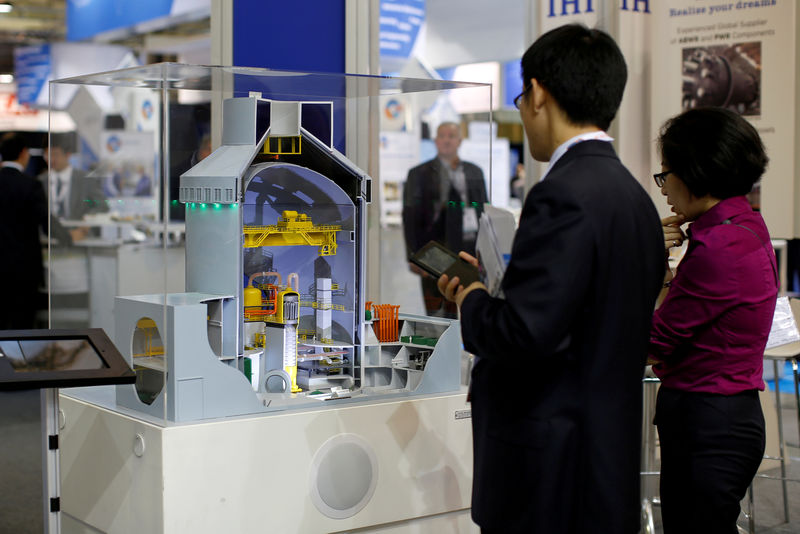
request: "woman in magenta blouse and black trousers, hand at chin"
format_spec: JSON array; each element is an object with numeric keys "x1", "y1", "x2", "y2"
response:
[{"x1": 649, "y1": 108, "x2": 778, "y2": 534}]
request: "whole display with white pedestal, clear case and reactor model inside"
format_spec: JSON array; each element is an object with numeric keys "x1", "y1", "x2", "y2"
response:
[{"x1": 49, "y1": 64, "x2": 490, "y2": 532}]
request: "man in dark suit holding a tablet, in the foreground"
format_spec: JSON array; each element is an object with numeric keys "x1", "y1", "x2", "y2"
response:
[{"x1": 439, "y1": 25, "x2": 665, "y2": 534}]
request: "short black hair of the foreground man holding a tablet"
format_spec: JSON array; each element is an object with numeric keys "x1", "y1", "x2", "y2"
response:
[{"x1": 522, "y1": 24, "x2": 628, "y2": 134}]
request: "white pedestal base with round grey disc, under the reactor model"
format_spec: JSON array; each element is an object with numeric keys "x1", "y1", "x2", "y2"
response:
[{"x1": 61, "y1": 393, "x2": 478, "y2": 534}]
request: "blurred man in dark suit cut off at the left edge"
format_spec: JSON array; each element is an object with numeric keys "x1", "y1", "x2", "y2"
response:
[{"x1": 0, "y1": 134, "x2": 48, "y2": 330}]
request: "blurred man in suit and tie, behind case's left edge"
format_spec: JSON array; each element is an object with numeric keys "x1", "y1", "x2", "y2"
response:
[{"x1": 41, "y1": 134, "x2": 108, "y2": 220}]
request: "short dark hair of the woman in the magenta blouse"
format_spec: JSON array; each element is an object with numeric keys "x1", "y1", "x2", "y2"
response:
[{"x1": 658, "y1": 108, "x2": 769, "y2": 199}]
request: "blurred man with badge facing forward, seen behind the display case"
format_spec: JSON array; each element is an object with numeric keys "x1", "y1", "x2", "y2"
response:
[{"x1": 403, "y1": 122, "x2": 488, "y2": 318}]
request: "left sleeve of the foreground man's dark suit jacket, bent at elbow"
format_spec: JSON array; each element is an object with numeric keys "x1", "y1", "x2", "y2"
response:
[{"x1": 461, "y1": 181, "x2": 595, "y2": 363}]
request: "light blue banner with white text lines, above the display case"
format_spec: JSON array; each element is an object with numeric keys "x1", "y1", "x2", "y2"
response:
[{"x1": 379, "y1": 0, "x2": 425, "y2": 59}]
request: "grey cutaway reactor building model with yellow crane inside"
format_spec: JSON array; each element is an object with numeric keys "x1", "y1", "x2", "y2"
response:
[{"x1": 115, "y1": 96, "x2": 460, "y2": 421}]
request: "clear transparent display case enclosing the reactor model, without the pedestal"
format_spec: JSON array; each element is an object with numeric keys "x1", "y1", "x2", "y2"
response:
[{"x1": 48, "y1": 64, "x2": 491, "y2": 424}]
